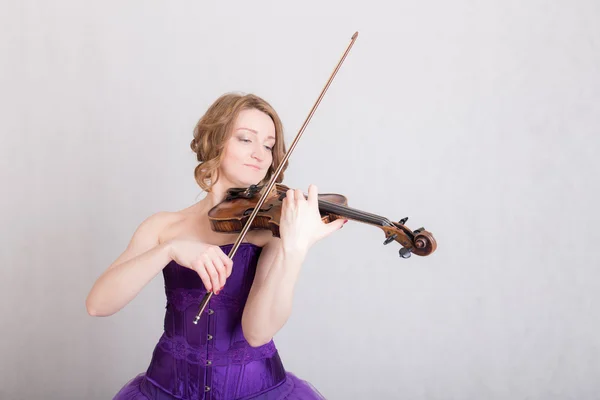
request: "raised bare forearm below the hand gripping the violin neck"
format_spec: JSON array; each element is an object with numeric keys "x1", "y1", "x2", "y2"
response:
[{"x1": 242, "y1": 242, "x2": 306, "y2": 347}]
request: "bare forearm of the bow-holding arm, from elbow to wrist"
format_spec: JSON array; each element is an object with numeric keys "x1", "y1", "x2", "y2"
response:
[{"x1": 86, "y1": 243, "x2": 171, "y2": 317}]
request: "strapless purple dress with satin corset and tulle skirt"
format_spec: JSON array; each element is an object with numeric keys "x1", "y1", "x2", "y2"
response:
[{"x1": 113, "y1": 243, "x2": 324, "y2": 400}]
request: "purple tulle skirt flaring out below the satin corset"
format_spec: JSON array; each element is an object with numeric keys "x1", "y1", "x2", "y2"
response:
[{"x1": 113, "y1": 372, "x2": 325, "y2": 400}]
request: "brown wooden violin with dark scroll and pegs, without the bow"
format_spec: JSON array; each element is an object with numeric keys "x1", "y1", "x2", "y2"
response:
[{"x1": 208, "y1": 183, "x2": 437, "y2": 258}]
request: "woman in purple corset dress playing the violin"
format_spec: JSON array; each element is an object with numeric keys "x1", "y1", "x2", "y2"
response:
[{"x1": 86, "y1": 93, "x2": 347, "y2": 400}]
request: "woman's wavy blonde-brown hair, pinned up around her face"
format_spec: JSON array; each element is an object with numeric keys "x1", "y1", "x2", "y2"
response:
[{"x1": 190, "y1": 93, "x2": 288, "y2": 192}]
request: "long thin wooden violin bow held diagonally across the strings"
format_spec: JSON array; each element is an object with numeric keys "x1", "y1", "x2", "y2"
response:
[{"x1": 194, "y1": 31, "x2": 358, "y2": 324}]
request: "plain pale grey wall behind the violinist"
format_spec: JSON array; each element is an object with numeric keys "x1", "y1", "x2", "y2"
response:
[{"x1": 0, "y1": 0, "x2": 600, "y2": 400}]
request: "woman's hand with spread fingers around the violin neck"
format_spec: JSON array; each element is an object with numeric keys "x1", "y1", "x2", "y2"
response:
[{"x1": 279, "y1": 184, "x2": 347, "y2": 251}]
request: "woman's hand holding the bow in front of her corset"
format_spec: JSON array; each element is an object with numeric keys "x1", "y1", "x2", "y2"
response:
[{"x1": 169, "y1": 239, "x2": 233, "y2": 294}]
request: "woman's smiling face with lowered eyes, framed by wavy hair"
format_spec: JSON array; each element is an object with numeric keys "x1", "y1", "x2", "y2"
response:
[{"x1": 220, "y1": 109, "x2": 275, "y2": 187}]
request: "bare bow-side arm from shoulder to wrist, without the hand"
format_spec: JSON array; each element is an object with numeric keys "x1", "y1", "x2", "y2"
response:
[{"x1": 85, "y1": 213, "x2": 177, "y2": 317}]
